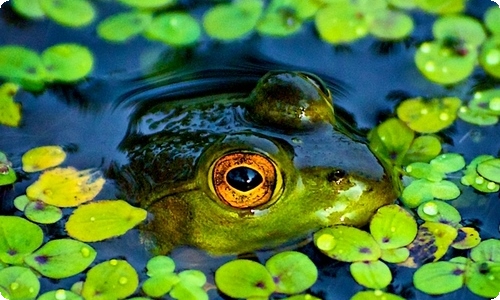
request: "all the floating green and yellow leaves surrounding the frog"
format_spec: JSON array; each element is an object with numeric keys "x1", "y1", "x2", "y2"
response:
[{"x1": 0, "y1": 0, "x2": 500, "y2": 300}]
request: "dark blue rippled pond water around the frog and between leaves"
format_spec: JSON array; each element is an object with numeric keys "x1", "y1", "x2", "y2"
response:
[{"x1": 0, "y1": 0, "x2": 500, "y2": 299}]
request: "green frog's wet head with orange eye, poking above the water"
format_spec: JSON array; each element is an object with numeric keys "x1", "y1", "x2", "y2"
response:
[{"x1": 117, "y1": 71, "x2": 397, "y2": 255}]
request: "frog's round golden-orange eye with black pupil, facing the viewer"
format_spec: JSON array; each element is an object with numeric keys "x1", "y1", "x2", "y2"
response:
[{"x1": 211, "y1": 152, "x2": 281, "y2": 209}]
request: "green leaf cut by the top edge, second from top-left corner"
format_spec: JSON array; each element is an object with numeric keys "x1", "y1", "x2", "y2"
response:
[{"x1": 38, "y1": 0, "x2": 95, "y2": 27}]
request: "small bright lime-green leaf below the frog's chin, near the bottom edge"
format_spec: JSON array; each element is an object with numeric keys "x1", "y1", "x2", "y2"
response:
[{"x1": 350, "y1": 260, "x2": 392, "y2": 289}]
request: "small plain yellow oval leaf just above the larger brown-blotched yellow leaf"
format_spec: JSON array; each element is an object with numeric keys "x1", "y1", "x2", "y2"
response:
[{"x1": 22, "y1": 146, "x2": 66, "y2": 172}]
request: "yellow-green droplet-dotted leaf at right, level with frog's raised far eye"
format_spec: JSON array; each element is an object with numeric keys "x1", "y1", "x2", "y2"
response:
[{"x1": 396, "y1": 97, "x2": 462, "y2": 133}]
